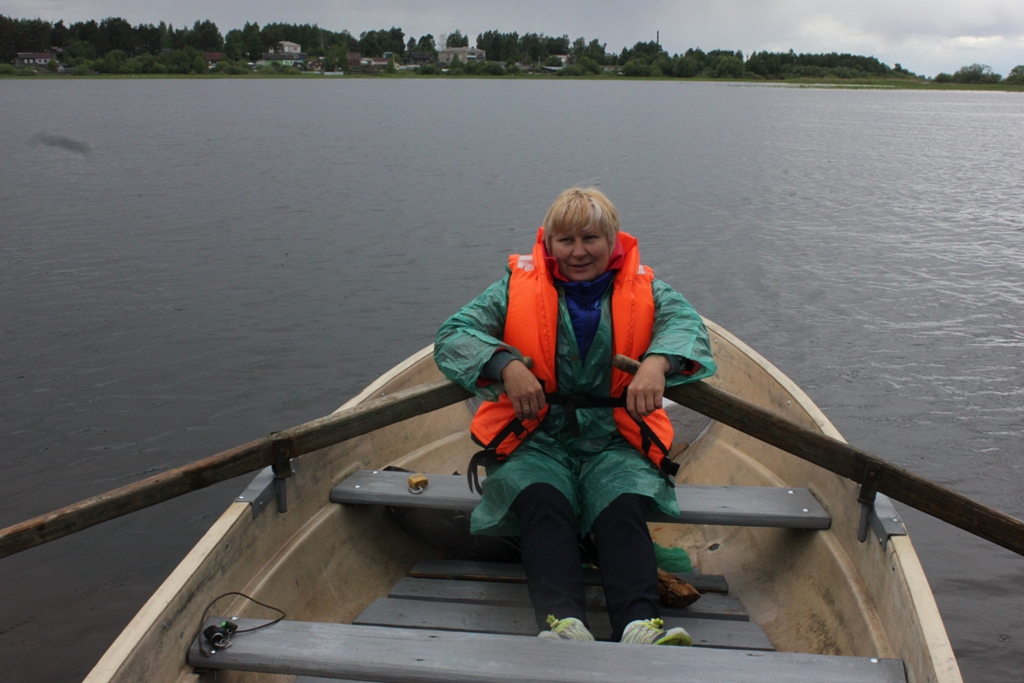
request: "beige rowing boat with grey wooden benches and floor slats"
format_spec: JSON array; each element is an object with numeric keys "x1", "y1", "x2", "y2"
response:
[{"x1": 86, "y1": 322, "x2": 962, "y2": 683}]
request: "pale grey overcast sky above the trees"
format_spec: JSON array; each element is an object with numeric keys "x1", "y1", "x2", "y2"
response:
[{"x1": 8, "y1": 0, "x2": 1024, "y2": 76}]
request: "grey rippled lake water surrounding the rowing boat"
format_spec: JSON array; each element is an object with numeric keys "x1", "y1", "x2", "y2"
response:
[{"x1": 0, "y1": 79, "x2": 1024, "y2": 682}]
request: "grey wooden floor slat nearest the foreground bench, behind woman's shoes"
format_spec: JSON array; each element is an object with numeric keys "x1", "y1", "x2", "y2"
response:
[{"x1": 352, "y1": 598, "x2": 774, "y2": 650}]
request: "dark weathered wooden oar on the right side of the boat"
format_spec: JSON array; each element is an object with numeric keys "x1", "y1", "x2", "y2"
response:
[{"x1": 613, "y1": 355, "x2": 1024, "y2": 555}]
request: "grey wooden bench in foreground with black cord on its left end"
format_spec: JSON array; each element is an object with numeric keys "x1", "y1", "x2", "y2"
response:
[{"x1": 188, "y1": 617, "x2": 906, "y2": 683}]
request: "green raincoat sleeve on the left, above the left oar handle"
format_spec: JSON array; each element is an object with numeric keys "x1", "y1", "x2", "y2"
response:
[{"x1": 434, "y1": 274, "x2": 522, "y2": 400}]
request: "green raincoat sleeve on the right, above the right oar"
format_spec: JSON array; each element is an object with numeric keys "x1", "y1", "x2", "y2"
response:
[{"x1": 644, "y1": 279, "x2": 717, "y2": 386}]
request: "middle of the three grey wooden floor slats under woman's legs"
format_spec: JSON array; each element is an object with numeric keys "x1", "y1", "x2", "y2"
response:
[{"x1": 388, "y1": 577, "x2": 751, "y2": 622}]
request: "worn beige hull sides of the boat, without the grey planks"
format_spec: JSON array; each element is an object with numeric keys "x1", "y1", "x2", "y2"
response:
[{"x1": 86, "y1": 322, "x2": 962, "y2": 683}]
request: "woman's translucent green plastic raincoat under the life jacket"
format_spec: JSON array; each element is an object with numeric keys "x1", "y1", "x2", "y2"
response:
[{"x1": 434, "y1": 268, "x2": 716, "y2": 536}]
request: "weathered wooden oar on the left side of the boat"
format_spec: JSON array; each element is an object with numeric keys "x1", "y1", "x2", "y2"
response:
[{"x1": 0, "y1": 380, "x2": 470, "y2": 558}]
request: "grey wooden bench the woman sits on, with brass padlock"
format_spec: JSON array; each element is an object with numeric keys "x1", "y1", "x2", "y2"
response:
[{"x1": 331, "y1": 470, "x2": 831, "y2": 529}]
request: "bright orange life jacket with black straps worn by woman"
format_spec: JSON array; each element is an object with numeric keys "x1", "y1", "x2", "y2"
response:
[{"x1": 470, "y1": 227, "x2": 679, "y2": 480}]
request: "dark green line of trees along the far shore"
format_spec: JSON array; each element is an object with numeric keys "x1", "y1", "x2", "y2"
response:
[{"x1": 0, "y1": 14, "x2": 1024, "y2": 85}]
